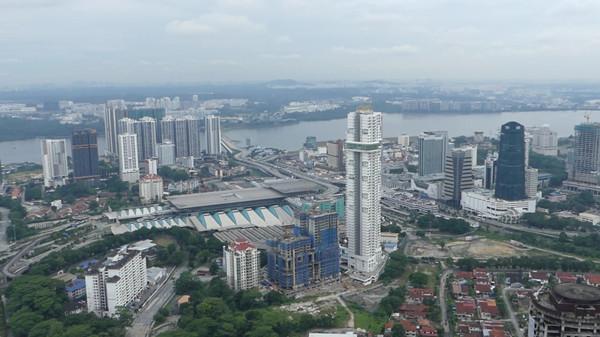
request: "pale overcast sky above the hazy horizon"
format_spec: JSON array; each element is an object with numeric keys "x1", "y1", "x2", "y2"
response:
[{"x1": 0, "y1": 0, "x2": 600, "y2": 88}]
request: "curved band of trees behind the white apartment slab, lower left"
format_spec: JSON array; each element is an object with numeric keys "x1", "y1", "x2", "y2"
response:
[{"x1": 28, "y1": 227, "x2": 222, "y2": 275}]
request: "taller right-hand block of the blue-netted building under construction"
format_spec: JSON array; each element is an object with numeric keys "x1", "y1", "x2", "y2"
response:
[{"x1": 299, "y1": 212, "x2": 340, "y2": 282}]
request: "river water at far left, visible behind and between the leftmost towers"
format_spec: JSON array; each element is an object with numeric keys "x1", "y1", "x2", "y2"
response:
[{"x1": 0, "y1": 136, "x2": 106, "y2": 164}]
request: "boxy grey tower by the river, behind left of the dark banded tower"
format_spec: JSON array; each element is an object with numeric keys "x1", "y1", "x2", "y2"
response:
[{"x1": 418, "y1": 131, "x2": 448, "y2": 176}]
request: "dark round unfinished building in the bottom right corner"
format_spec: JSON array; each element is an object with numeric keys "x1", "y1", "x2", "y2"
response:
[{"x1": 528, "y1": 283, "x2": 600, "y2": 337}]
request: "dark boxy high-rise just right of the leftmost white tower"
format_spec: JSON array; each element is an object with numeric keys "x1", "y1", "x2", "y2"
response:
[{"x1": 71, "y1": 129, "x2": 100, "y2": 180}]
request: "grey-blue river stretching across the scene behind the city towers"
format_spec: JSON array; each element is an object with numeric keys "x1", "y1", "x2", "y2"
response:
[{"x1": 0, "y1": 111, "x2": 600, "y2": 163}]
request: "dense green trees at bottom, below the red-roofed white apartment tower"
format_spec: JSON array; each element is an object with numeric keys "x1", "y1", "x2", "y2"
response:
[{"x1": 159, "y1": 273, "x2": 336, "y2": 337}]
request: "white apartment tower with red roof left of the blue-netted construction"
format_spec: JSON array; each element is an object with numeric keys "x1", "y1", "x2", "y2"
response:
[{"x1": 223, "y1": 239, "x2": 261, "y2": 291}]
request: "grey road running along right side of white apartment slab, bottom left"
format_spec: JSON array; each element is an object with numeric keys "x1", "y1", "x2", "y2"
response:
[{"x1": 127, "y1": 266, "x2": 186, "y2": 337}]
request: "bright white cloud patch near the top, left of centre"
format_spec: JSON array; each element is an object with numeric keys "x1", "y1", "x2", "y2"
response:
[{"x1": 165, "y1": 13, "x2": 265, "y2": 35}]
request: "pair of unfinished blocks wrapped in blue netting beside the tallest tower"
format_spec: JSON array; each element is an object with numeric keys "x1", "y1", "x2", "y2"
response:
[{"x1": 267, "y1": 217, "x2": 340, "y2": 290}]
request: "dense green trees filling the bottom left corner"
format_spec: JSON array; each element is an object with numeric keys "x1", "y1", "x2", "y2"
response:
[{"x1": 6, "y1": 275, "x2": 131, "y2": 337}]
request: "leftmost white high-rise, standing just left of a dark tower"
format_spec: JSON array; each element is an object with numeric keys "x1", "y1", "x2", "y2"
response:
[{"x1": 41, "y1": 139, "x2": 69, "y2": 187}]
